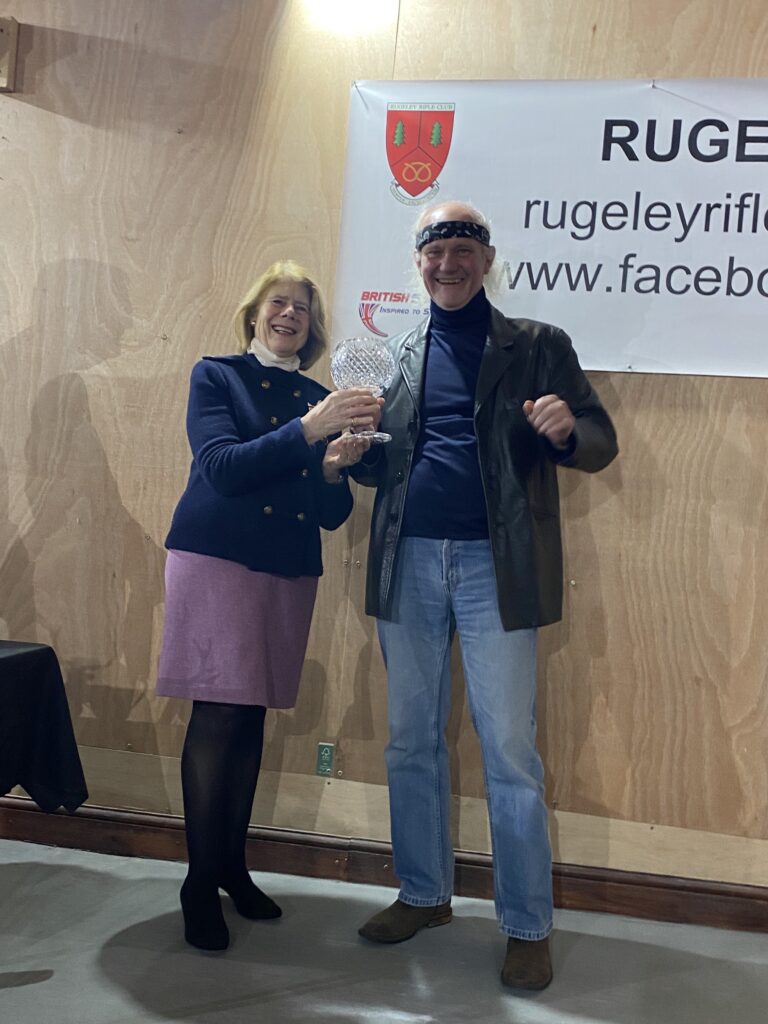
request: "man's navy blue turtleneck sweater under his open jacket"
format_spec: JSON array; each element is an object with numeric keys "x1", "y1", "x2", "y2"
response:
[{"x1": 401, "y1": 289, "x2": 490, "y2": 541}]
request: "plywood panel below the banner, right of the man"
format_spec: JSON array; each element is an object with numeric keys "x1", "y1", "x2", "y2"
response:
[{"x1": 543, "y1": 374, "x2": 768, "y2": 838}]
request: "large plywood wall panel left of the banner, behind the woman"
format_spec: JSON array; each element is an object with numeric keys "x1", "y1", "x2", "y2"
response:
[{"x1": 0, "y1": 0, "x2": 396, "y2": 770}]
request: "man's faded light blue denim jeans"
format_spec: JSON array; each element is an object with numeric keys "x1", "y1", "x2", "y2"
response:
[{"x1": 378, "y1": 537, "x2": 552, "y2": 939}]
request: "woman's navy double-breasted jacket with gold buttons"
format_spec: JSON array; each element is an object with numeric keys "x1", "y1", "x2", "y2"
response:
[{"x1": 165, "y1": 353, "x2": 352, "y2": 577}]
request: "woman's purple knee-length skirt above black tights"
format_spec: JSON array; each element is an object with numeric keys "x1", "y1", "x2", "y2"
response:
[{"x1": 157, "y1": 551, "x2": 317, "y2": 708}]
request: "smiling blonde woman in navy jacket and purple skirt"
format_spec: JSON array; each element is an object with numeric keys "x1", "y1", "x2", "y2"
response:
[{"x1": 158, "y1": 261, "x2": 379, "y2": 949}]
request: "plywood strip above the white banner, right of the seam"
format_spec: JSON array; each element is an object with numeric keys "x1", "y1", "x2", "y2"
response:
[{"x1": 393, "y1": 0, "x2": 768, "y2": 81}]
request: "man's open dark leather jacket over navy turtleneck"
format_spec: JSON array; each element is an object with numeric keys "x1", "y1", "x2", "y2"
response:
[{"x1": 352, "y1": 306, "x2": 618, "y2": 630}]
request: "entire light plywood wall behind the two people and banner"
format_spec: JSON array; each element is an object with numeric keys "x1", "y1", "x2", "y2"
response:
[{"x1": 0, "y1": 0, "x2": 768, "y2": 885}]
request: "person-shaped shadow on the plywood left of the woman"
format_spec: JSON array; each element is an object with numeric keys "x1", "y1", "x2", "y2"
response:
[{"x1": 0, "y1": 260, "x2": 175, "y2": 799}]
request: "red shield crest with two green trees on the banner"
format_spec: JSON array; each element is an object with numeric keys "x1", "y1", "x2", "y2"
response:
[{"x1": 386, "y1": 103, "x2": 456, "y2": 206}]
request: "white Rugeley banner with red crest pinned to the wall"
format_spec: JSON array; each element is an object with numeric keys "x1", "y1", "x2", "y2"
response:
[{"x1": 334, "y1": 79, "x2": 768, "y2": 377}]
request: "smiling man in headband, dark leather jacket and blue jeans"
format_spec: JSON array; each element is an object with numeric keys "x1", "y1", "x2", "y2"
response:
[{"x1": 353, "y1": 195, "x2": 617, "y2": 989}]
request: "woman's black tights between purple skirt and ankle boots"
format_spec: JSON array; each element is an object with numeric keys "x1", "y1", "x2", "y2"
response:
[{"x1": 181, "y1": 700, "x2": 266, "y2": 890}]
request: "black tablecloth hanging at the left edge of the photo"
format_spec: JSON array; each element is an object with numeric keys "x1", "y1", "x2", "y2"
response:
[{"x1": 0, "y1": 640, "x2": 88, "y2": 812}]
